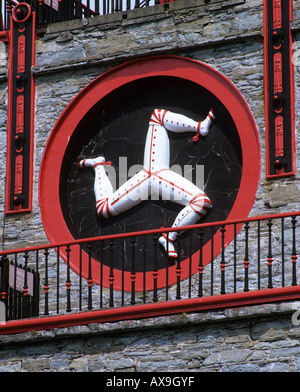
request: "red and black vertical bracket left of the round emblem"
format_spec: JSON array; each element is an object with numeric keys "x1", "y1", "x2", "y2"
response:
[{"x1": 5, "y1": 3, "x2": 35, "y2": 214}]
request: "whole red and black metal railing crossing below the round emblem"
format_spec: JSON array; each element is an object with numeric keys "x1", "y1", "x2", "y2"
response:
[{"x1": 0, "y1": 211, "x2": 300, "y2": 333}]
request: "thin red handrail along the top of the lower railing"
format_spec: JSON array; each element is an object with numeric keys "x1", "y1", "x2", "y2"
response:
[{"x1": 0, "y1": 211, "x2": 300, "y2": 256}]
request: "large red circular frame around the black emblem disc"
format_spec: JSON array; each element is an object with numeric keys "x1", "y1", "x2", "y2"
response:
[{"x1": 39, "y1": 56, "x2": 260, "y2": 291}]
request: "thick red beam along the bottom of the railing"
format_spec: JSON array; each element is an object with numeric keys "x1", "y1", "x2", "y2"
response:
[{"x1": 0, "y1": 286, "x2": 300, "y2": 335}]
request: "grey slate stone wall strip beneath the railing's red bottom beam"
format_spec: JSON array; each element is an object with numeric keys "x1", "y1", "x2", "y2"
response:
[{"x1": 0, "y1": 304, "x2": 300, "y2": 374}]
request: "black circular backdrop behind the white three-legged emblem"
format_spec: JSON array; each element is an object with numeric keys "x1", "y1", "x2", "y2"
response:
[{"x1": 60, "y1": 76, "x2": 242, "y2": 272}]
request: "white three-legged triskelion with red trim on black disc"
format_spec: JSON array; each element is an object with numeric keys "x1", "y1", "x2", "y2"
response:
[{"x1": 78, "y1": 109, "x2": 215, "y2": 258}]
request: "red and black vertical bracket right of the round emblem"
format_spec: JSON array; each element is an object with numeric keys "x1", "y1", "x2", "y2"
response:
[{"x1": 264, "y1": 0, "x2": 296, "y2": 179}]
